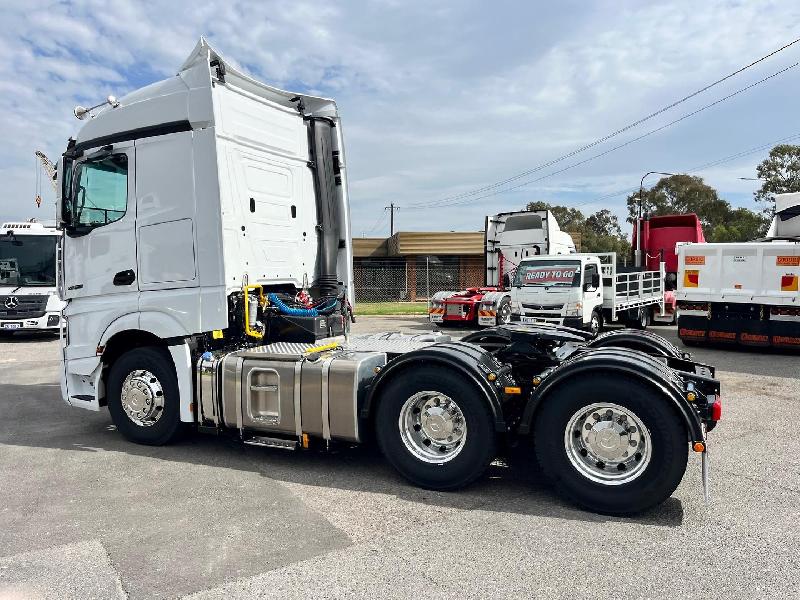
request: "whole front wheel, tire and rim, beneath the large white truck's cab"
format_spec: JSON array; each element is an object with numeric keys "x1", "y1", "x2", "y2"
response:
[{"x1": 107, "y1": 347, "x2": 181, "y2": 446}]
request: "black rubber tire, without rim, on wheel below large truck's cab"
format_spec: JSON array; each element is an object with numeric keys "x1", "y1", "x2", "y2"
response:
[{"x1": 107, "y1": 347, "x2": 183, "y2": 446}]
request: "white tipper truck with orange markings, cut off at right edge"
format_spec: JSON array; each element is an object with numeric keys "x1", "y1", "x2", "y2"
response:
[{"x1": 676, "y1": 193, "x2": 800, "y2": 349}]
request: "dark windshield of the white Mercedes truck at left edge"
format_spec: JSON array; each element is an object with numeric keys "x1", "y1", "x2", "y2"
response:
[{"x1": 0, "y1": 235, "x2": 56, "y2": 287}]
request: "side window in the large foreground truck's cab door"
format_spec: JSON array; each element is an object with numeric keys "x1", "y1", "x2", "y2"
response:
[{"x1": 71, "y1": 154, "x2": 128, "y2": 228}]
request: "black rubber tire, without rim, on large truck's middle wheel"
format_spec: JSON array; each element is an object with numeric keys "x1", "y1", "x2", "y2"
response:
[{"x1": 375, "y1": 367, "x2": 496, "y2": 490}]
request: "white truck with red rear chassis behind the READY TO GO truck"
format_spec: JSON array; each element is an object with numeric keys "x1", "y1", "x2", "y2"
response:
[{"x1": 428, "y1": 210, "x2": 575, "y2": 327}]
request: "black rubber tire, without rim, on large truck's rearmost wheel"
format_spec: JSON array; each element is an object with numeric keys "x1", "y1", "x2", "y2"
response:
[{"x1": 534, "y1": 374, "x2": 689, "y2": 515}]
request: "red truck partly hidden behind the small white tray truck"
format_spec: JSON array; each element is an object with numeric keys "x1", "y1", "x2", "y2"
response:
[{"x1": 631, "y1": 213, "x2": 706, "y2": 324}]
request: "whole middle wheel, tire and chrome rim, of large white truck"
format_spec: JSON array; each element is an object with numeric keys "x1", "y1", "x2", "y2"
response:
[{"x1": 375, "y1": 367, "x2": 495, "y2": 490}]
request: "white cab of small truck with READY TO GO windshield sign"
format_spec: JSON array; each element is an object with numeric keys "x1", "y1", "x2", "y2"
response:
[{"x1": 511, "y1": 254, "x2": 603, "y2": 335}]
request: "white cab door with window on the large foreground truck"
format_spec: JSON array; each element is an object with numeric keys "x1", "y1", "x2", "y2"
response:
[{"x1": 62, "y1": 141, "x2": 139, "y2": 359}]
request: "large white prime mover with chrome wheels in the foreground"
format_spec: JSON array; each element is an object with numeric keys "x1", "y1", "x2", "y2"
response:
[{"x1": 53, "y1": 40, "x2": 721, "y2": 513}]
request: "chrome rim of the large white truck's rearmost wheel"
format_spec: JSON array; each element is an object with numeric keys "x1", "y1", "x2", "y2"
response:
[{"x1": 564, "y1": 402, "x2": 653, "y2": 485}]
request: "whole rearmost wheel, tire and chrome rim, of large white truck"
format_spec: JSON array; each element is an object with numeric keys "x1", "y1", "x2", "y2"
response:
[{"x1": 534, "y1": 375, "x2": 688, "y2": 514}]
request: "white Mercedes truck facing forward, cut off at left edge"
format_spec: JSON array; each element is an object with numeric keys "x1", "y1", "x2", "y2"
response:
[{"x1": 0, "y1": 222, "x2": 64, "y2": 333}]
